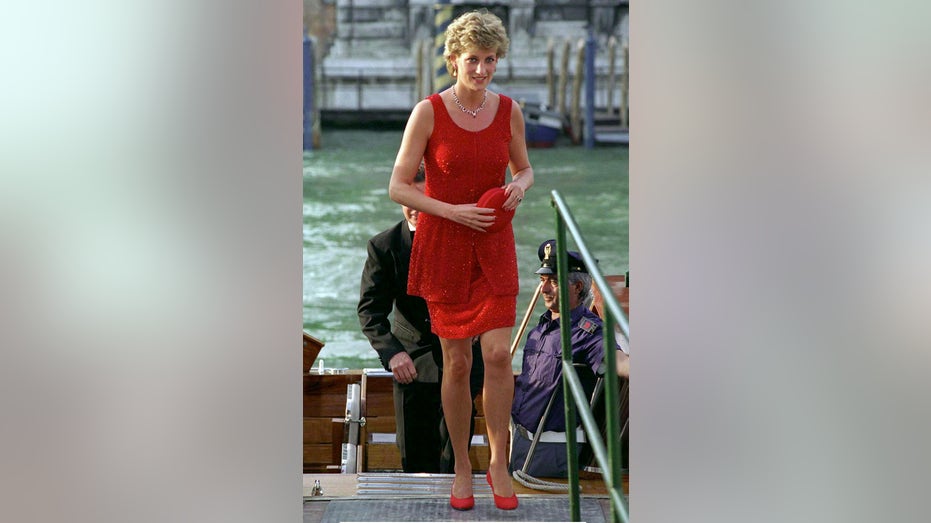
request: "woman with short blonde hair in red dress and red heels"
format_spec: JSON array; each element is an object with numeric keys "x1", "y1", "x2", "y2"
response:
[{"x1": 389, "y1": 10, "x2": 533, "y2": 510}]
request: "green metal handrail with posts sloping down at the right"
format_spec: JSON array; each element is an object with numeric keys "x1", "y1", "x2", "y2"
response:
[{"x1": 551, "y1": 190, "x2": 630, "y2": 523}]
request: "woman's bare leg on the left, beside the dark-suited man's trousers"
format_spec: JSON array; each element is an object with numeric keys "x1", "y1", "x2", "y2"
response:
[{"x1": 440, "y1": 338, "x2": 476, "y2": 498}]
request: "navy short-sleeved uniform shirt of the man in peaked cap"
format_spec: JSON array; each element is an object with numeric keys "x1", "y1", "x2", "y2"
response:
[{"x1": 511, "y1": 306, "x2": 620, "y2": 432}]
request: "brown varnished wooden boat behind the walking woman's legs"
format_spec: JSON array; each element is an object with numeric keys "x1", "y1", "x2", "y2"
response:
[{"x1": 303, "y1": 275, "x2": 629, "y2": 523}]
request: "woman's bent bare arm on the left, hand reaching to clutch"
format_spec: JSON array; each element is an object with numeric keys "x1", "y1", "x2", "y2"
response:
[{"x1": 388, "y1": 100, "x2": 495, "y2": 232}]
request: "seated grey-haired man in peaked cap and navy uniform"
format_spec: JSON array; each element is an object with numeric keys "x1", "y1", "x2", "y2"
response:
[{"x1": 510, "y1": 240, "x2": 627, "y2": 478}]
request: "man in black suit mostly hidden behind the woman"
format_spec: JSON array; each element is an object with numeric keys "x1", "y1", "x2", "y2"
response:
[{"x1": 358, "y1": 168, "x2": 484, "y2": 473}]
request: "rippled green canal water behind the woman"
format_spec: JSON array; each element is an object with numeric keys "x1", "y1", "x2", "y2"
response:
[{"x1": 303, "y1": 129, "x2": 629, "y2": 369}]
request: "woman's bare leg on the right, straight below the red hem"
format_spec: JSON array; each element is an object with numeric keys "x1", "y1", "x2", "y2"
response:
[{"x1": 482, "y1": 328, "x2": 514, "y2": 497}]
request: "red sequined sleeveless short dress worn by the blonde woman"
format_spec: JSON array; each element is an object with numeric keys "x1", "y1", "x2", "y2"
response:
[{"x1": 407, "y1": 94, "x2": 518, "y2": 339}]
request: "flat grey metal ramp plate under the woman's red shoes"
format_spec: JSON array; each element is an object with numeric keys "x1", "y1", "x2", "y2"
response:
[{"x1": 314, "y1": 495, "x2": 605, "y2": 523}]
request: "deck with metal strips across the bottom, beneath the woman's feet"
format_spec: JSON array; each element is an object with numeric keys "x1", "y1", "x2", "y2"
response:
[{"x1": 304, "y1": 473, "x2": 628, "y2": 523}]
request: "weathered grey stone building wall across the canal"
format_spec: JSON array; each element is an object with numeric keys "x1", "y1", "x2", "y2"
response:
[{"x1": 305, "y1": 0, "x2": 629, "y2": 115}]
